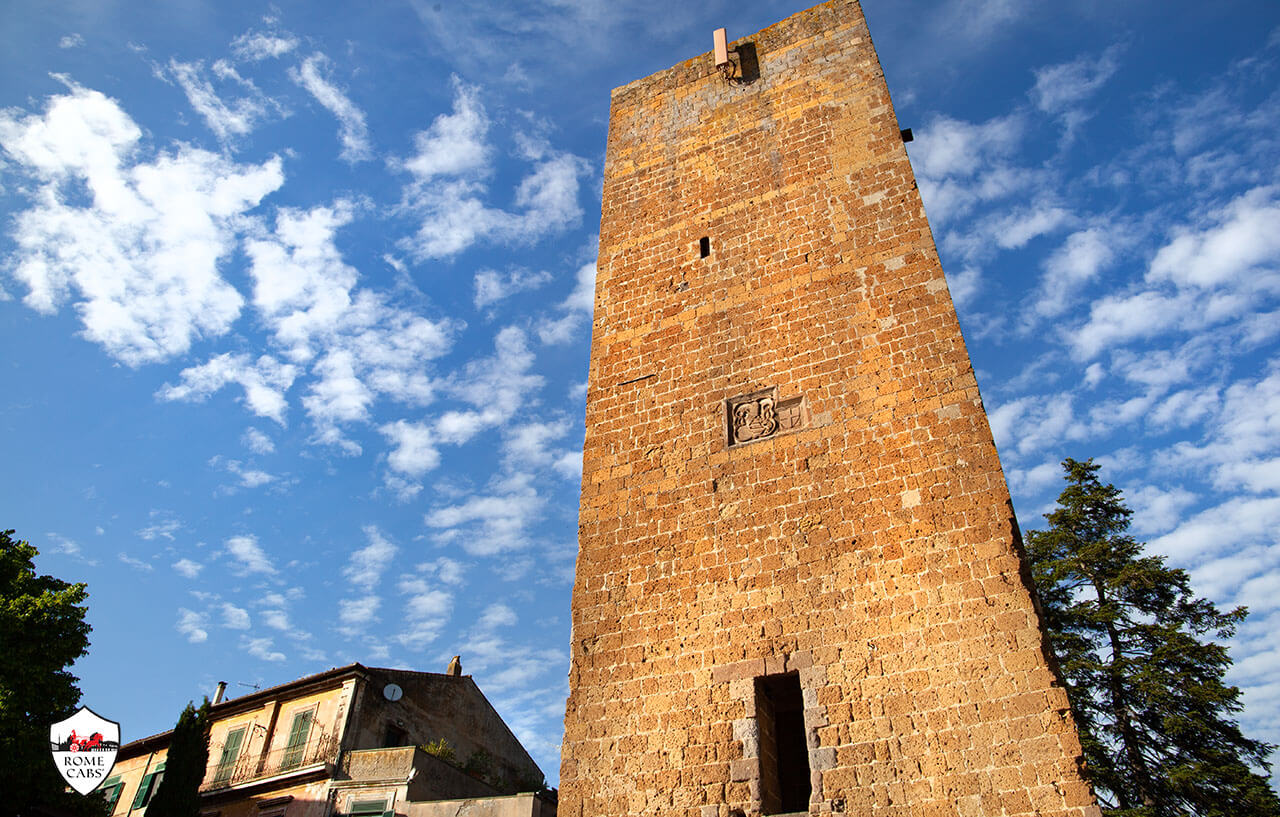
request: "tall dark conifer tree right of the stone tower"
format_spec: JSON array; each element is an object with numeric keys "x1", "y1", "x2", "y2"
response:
[{"x1": 1027, "y1": 458, "x2": 1280, "y2": 817}]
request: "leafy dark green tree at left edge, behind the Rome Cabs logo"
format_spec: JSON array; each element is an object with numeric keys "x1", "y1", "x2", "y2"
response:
[{"x1": 0, "y1": 530, "x2": 105, "y2": 814}]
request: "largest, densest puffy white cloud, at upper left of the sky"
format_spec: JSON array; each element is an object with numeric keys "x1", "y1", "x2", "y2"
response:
[{"x1": 0, "y1": 85, "x2": 284, "y2": 366}]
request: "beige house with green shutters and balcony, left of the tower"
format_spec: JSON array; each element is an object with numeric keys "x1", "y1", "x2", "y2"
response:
[{"x1": 100, "y1": 663, "x2": 556, "y2": 817}]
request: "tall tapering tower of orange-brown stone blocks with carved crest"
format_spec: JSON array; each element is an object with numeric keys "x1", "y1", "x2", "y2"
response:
[{"x1": 559, "y1": 0, "x2": 1097, "y2": 817}]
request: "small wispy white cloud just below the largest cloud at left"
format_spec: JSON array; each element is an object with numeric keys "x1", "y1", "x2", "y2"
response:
[{"x1": 156, "y1": 352, "x2": 298, "y2": 425}]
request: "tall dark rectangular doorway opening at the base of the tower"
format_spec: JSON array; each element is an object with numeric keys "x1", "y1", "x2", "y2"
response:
[{"x1": 755, "y1": 672, "x2": 812, "y2": 814}]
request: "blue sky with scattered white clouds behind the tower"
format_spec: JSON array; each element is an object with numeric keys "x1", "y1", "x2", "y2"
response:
[{"x1": 0, "y1": 0, "x2": 1280, "y2": 781}]
